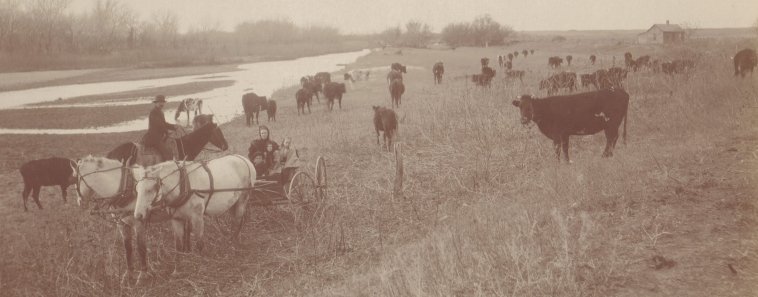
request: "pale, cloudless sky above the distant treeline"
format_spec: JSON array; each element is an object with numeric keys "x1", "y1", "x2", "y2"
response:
[{"x1": 70, "y1": 0, "x2": 758, "y2": 34}]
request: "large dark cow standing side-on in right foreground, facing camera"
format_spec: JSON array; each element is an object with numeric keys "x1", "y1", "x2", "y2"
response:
[{"x1": 513, "y1": 89, "x2": 629, "y2": 162}]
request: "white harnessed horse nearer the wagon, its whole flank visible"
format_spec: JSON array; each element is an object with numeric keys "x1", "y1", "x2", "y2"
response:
[{"x1": 133, "y1": 155, "x2": 256, "y2": 268}]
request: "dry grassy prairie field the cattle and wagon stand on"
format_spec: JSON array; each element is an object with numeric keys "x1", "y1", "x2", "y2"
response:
[{"x1": 0, "y1": 33, "x2": 758, "y2": 296}]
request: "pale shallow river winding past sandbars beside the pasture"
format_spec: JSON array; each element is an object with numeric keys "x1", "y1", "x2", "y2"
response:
[{"x1": 0, "y1": 49, "x2": 370, "y2": 134}]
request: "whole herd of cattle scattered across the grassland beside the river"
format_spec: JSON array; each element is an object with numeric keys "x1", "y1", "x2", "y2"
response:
[{"x1": 13, "y1": 45, "x2": 758, "y2": 210}]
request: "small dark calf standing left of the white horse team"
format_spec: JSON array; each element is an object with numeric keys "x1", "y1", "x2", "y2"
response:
[{"x1": 19, "y1": 157, "x2": 76, "y2": 211}]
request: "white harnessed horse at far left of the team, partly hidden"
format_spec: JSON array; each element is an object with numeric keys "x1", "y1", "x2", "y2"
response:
[{"x1": 73, "y1": 155, "x2": 165, "y2": 283}]
